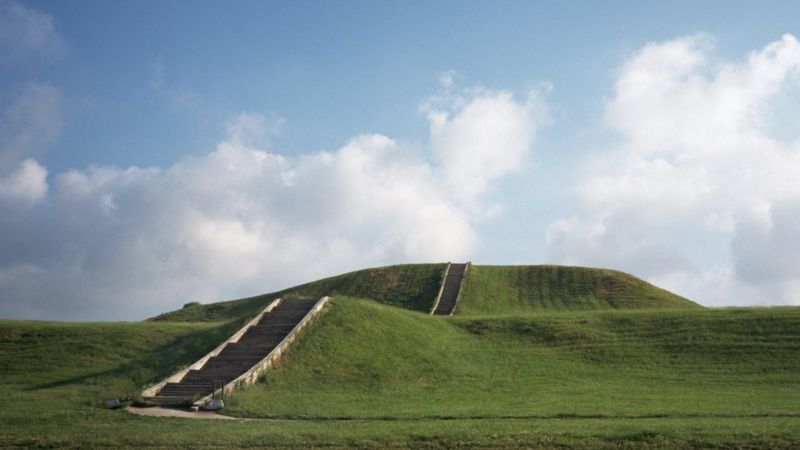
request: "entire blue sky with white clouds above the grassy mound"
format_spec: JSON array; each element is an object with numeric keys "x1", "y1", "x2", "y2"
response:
[{"x1": 0, "y1": 1, "x2": 800, "y2": 320}]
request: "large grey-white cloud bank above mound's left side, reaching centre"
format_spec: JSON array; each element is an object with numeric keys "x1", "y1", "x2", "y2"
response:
[{"x1": 0, "y1": 86, "x2": 537, "y2": 320}]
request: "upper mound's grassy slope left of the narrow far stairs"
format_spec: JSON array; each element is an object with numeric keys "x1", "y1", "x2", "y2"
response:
[{"x1": 149, "y1": 264, "x2": 445, "y2": 322}]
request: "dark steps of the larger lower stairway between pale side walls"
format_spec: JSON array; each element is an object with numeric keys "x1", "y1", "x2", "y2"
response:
[{"x1": 152, "y1": 299, "x2": 318, "y2": 405}]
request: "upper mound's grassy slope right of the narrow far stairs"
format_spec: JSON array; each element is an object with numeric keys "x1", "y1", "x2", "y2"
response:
[{"x1": 456, "y1": 266, "x2": 699, "y2": 315}]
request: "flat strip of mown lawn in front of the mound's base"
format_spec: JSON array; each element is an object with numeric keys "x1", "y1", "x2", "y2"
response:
[{"x1": 0, "y1": 405, "x2": 800, "y2": 449}]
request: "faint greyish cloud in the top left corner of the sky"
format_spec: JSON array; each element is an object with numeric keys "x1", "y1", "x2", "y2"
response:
[{"x1": 0, "y1": 2, "x2": 65, "y2": 63}]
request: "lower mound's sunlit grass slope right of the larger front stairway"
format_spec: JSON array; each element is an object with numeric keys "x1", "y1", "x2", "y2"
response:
[{"x1": 223, "y1": 299, "x2": 800, "y2": 420}]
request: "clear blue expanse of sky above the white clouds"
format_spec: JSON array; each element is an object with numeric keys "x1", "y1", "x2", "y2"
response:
[{"x1": 18, "y1": 1, "x2": 797, "y2": 170}]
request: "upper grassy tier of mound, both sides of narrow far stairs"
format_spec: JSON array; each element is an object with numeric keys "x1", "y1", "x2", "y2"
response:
[{"x1": 149, "y1": 264, "x2": 699, "y2": 322}]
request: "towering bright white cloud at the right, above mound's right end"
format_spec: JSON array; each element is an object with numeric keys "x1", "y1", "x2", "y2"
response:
[{"x1": 547, "y1": 35, "x2": 800, "y2": 304}]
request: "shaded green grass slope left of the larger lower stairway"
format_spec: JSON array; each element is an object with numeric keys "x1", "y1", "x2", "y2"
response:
[{"x1": 0, "y1": 321, "x2": 241, "y2": 401}]
